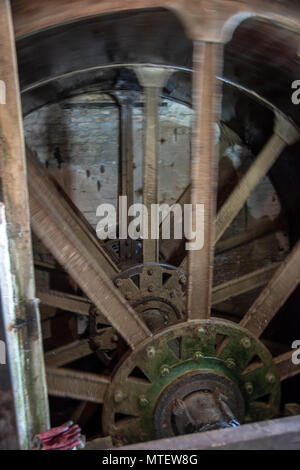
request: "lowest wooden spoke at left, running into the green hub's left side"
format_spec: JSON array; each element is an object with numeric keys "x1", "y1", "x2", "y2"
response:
[{"x1": 47, "y1": 367, "x2": 110, "y2": 403}]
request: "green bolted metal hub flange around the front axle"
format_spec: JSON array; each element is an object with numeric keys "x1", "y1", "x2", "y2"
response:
[{"x1": 103, "y1": 318, "x2": 280, "y2": 444}]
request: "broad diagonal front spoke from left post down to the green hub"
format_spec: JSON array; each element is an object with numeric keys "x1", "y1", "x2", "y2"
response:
[{"x1": 30, "y1": 188, "x2": 151, "y2": 347}]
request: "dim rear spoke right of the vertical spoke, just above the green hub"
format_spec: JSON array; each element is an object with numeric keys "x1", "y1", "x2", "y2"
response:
[{"x1": 212, "y1": 263, "x2": 279, "y2": 305}]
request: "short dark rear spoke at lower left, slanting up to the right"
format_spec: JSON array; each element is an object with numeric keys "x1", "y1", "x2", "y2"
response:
[{"x1": 45, "y1": 339, "x2": 93, "y2": 367}]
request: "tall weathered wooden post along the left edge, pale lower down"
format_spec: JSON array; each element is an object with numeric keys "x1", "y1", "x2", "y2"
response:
[{"x1": 0, "y1": 0, "x2": 49, "y2": 449}]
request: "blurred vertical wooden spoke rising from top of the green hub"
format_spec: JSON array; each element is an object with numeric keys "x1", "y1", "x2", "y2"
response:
[{"x1": 187, "y1": 41, "x2": 222, "y2": 319}]
